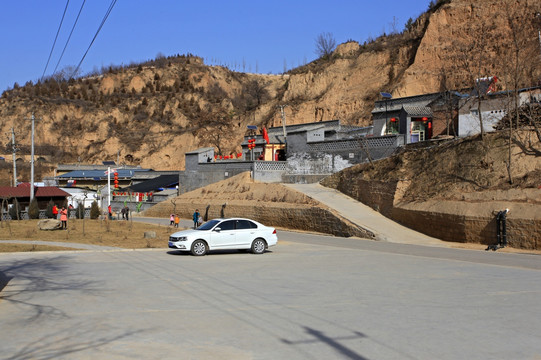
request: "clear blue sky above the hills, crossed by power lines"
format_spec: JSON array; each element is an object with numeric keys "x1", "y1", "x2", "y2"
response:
[{"x1": 0, "y1": 0, "x2": 430, "y2": 92}]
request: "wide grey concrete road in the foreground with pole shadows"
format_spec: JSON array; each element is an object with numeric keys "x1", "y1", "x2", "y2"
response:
[{"x1": 0, "y1": 232, "x2": 541, "y2": 360}]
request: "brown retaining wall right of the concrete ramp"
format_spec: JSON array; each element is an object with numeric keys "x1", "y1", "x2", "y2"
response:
[{"x1": 322, "y1": 176, "x2": 541, "y2": 250}]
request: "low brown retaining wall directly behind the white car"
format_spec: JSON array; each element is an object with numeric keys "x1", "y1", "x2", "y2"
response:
[{"x1": 143, "y1": 201, "x2": 374, "y2": 239}]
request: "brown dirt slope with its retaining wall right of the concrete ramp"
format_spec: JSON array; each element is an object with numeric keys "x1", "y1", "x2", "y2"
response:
[{"x1": 323, "y1": 130, "x2": 541, "y2": 250}]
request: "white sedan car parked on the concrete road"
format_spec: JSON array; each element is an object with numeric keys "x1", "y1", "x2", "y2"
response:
[{"x1": 169, "y1": 218, "x2": 278, "y2": 256}]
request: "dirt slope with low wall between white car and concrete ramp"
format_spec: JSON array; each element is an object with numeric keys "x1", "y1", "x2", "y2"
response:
[{"x1": 142, "y1": 172, "x2": 374, "y2": 239}]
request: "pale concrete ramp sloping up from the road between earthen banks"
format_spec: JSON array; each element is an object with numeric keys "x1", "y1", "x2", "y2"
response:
[{"x1": 286, "y1": 183, "x2": 449, "y2": 246}]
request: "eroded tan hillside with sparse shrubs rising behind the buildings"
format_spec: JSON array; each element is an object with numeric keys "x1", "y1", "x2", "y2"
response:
[{"x1": 0, "y1": 0, "x2": 540, "y2": 186}]
